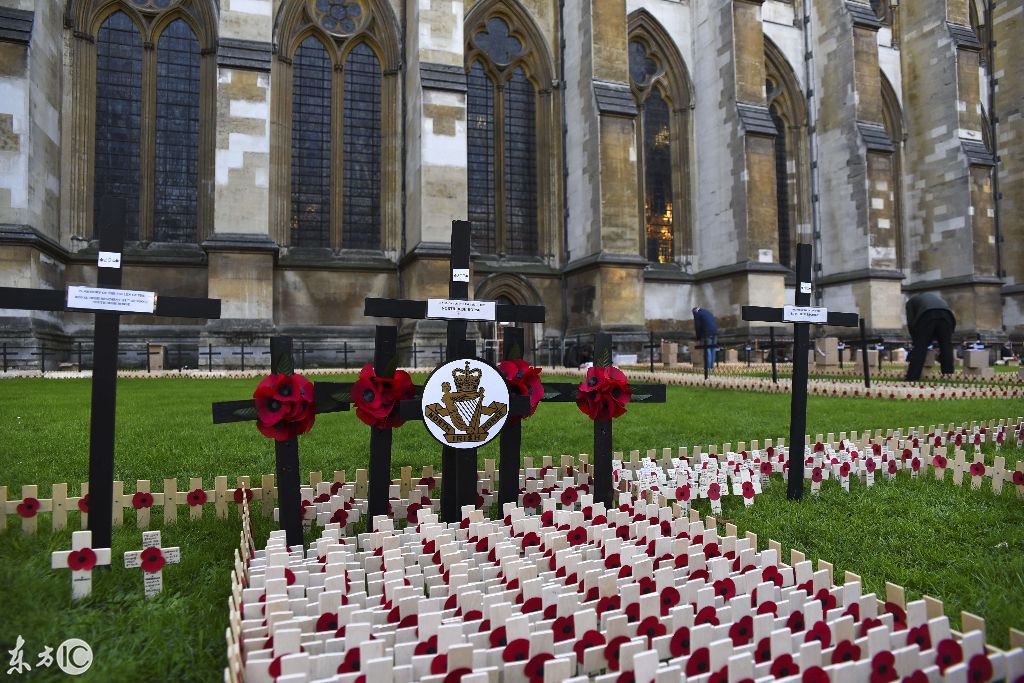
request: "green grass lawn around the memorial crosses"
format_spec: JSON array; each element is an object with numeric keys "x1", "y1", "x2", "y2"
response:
[{"x1": 0, "y1": 378, "x2": 1024, "y2": 681}]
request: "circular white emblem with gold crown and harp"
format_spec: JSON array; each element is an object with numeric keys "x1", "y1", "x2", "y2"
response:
[{"x1": 423, "y1": 358, "x2": 509, "y2": 449}]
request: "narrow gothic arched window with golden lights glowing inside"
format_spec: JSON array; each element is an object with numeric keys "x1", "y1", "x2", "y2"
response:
[{"x1": 629, "y1": 10, "x2": 691, "y2": 263}]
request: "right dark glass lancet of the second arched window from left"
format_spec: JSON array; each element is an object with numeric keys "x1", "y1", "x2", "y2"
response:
[{"x1": 342, "y1": 43, "x2": 381, "y2": 249}]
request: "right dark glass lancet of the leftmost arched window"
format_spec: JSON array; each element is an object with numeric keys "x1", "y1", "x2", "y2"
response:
[{"x1": 154, "y1": 19, "x2": 200, "y2": 242}]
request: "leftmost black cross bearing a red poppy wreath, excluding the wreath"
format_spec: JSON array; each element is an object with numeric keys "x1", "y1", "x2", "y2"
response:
[{"x1": 213, "y1": 337, "x2": 348, "y2": 547}]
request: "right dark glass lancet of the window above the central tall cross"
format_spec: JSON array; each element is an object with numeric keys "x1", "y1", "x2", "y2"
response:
[{"x1": 504, "y1": 69, "x2": 537, "y2": 255}]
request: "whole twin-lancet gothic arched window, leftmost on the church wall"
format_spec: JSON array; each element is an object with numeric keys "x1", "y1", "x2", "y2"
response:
[{"x1": 82, "y1": 0, "x2": 216, "y2": 243}]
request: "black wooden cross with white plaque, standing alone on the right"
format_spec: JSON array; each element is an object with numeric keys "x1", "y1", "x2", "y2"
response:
[{"x1": 742, "y1": 244, "x2": 860, "y2": 501}]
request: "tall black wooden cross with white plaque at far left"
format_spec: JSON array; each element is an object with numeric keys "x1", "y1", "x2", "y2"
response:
[{"x1": 0, "y1": 197, "x2": 220, "y2": 548}]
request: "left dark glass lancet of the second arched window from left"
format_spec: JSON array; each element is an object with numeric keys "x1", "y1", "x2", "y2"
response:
[{"x1": 292, "y1": 37, "x2": 331, "y2": 247}]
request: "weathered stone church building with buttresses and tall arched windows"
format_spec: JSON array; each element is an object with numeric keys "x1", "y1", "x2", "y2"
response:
[{"x1": 0, "y1": 0, "x2": 1024, "y2": 362}]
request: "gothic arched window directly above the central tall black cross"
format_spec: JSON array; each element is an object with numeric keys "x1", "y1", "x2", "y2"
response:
[{"x1": 466, "y1": 16, "x2": 538, "y2": 256}]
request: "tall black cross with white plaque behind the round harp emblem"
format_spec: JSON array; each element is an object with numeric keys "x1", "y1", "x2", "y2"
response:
[{"x1": 364, "y1": 220, "x2": 544, "y2": 521}]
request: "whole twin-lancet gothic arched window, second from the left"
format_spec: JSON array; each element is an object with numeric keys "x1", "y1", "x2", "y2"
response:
[{"x1": 271, "y1": 0, "x2": 400, "y2": 251}]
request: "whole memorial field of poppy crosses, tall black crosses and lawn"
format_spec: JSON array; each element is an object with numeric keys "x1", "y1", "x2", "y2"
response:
[{"x1": 0, "y1": 225, "x2": 1024, "y2": 683}]
